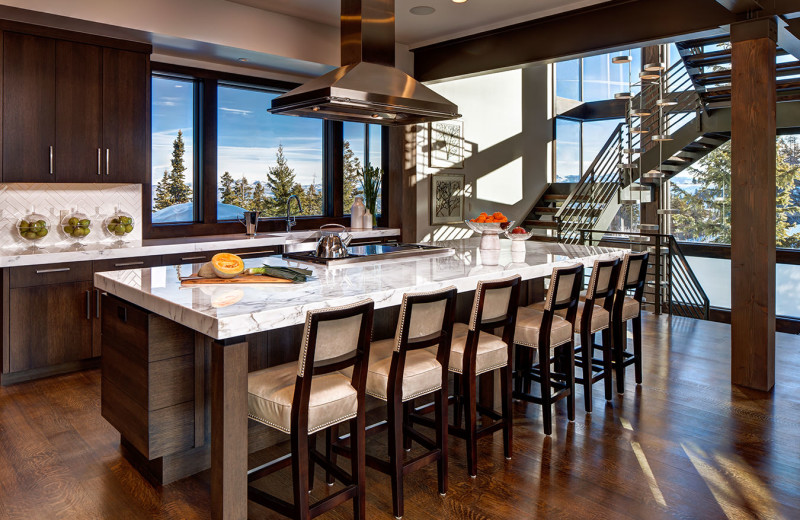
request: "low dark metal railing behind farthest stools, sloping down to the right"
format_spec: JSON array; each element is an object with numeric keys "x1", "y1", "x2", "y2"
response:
[{"x1": 580, "y1": 229, "x2": 710, "y2": 320}]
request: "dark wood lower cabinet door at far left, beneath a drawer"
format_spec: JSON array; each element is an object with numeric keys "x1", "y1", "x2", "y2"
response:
[{"x1": 9, "y1": 282, "x2": 93, "y2": 372}]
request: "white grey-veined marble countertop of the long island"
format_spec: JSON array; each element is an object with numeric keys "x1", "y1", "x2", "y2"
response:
[{"x1": 95, "y1": 238, "x2": 625, "y2": 339}]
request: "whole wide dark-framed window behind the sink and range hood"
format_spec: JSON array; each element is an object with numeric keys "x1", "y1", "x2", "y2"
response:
[{"x1": 148, "y1": 62, "x2": 389, "y2": 238}]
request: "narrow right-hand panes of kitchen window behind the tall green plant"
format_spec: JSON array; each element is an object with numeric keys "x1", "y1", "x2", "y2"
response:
[{"x1": 342, "y1": 123, "x2": 383, "y2": 215}]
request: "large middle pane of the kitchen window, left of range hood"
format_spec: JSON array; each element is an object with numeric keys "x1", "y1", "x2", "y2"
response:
[{"x1": 217, "y1": 85, "x2": 325, "y2": 221}]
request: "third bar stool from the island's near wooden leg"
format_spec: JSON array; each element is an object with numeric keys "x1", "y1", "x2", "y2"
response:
[{"x1": 411, "y1": 276, "x2": 521, "y2": 478}]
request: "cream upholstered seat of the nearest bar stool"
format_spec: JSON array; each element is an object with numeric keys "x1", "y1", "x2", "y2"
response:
[{"x1": 247, "y1": 362, "x2": 358, "y2": 434}]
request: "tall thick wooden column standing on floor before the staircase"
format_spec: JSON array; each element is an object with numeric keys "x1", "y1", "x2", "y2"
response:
[{"x1": 731, "y1": 18, "x2": 777, "y2": 391}]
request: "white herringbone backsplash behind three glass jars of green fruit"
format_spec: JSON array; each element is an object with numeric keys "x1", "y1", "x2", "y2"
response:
[{"x1": 0, "y1": 183, "x2": 142, "y2": 249}]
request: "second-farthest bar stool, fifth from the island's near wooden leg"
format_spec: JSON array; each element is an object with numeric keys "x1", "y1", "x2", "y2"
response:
[{"x1": 572, "y1": 258, "x2": 621, "y2": 412}]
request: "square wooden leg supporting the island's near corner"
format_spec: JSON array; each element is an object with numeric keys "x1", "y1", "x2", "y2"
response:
[{"x1": 211, "y1": 338, "x2": 247, "y2": 520}]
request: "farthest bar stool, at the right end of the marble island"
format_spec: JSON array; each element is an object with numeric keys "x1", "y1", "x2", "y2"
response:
[{"x1": 612, "y1": 251, "x2": 650, "y2": 394}]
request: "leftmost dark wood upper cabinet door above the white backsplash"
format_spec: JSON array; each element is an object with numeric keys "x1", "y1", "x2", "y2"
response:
[{"x1": 3, "y1": 32, "x2": 58, "y2": 182}]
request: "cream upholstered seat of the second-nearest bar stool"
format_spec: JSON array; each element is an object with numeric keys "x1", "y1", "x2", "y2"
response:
[{"x1": 345, "y1": 338, "x2": 442, "y2": 402}]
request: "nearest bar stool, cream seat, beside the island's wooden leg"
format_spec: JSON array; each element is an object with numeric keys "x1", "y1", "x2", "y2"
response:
[{"x1": 247, "y1": 299, "x2": 374, "y2": 519}]
